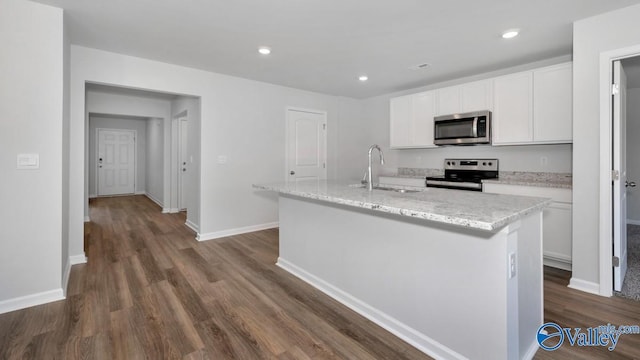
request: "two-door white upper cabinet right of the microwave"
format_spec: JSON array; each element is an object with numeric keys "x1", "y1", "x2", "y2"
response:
[{"x1": 492, "y1": 63, "x2": 573, "y2": 145}]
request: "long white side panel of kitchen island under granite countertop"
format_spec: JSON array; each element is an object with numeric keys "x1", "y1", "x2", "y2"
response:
[{"x1": 278, "y1": 195, "x2": 542, "y2": 359}]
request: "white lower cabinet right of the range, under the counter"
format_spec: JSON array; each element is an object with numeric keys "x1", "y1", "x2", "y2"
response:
[{"x1": 483, "y1": 183, "x2": 572, "y2": 271}]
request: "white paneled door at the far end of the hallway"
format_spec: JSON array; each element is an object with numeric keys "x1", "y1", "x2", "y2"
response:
[{"x1": 97, "y1": 129, "x2": 136, "y2": 196}]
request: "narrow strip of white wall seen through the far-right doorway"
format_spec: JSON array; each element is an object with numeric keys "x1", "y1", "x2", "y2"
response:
[{"x1": 627, "y1": 88, "x2": 640, "y2": 225}]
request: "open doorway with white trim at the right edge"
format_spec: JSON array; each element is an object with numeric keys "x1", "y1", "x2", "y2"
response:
[{"x1": 600, "y1": 46, "x2": 640, "y2": 299}]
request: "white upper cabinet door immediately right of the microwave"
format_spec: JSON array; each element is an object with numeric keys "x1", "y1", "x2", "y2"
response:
[{"x1": 492, "y1": 71, "x2": 533, "y2": 145}]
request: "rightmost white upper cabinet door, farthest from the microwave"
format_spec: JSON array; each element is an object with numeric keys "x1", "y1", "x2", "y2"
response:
[{"x1": 533, "y1": 63, "x2": 573, "y2": 143}]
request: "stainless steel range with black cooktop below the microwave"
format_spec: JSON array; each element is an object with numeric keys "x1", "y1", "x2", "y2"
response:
[{"x1": 427, "y1": 159, "x2": 498, "y2": 191}]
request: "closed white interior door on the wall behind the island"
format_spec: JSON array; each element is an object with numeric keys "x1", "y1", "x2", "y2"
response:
[{"x1": 287, "y1": 109, "x2": 327, "y2": 181}]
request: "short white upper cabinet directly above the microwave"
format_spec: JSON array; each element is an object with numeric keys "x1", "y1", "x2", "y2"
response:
[{"x1": 436, "y1": 80, "x2": 493, "y2": 115}]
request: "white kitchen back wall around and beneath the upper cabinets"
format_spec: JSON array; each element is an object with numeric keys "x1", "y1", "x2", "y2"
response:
[{"x1": 360, "y1": 57, "x2": 572, "y2": 176}]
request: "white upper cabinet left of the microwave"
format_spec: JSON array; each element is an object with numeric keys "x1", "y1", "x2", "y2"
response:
[{"x1": 389, "y1": 91, "x2": 436, "y2": 149}]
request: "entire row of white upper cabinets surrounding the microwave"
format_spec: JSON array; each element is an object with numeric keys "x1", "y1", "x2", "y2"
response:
[{"x1": 390, "y1": 62, "x2": 573, "y2": 149}]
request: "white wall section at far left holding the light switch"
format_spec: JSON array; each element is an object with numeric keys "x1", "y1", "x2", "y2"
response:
[{"x1": 0, "y1": 0, "x2": 64, "y2": 312}]
